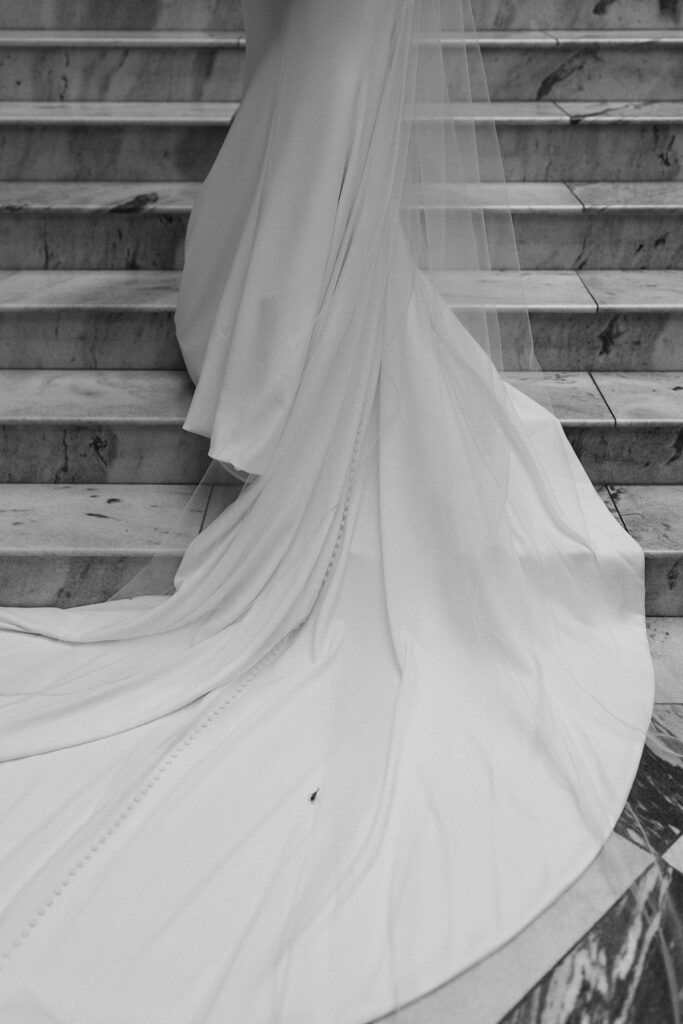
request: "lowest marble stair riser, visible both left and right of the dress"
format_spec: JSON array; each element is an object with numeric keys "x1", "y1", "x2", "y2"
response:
[{"x1": 0, "y1": 550, "x2": 671, "y2": 615}]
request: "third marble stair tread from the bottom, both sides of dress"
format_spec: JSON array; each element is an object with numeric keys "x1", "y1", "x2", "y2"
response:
[{"x1": 0, "y1": 270, "x2": 683, "y2": 313}]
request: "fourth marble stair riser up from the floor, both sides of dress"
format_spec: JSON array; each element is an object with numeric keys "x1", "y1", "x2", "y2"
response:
[{"x1": 5, "y1": 210, "x2": 683, "y2": 270}]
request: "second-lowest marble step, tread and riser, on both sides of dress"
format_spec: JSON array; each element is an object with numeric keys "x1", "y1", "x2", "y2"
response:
[{"x1": 0, "y1": 370, "x2": 683, "y2": 484}]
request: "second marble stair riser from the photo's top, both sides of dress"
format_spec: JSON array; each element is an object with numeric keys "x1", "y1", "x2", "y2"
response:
[{"x1": 5, "y1": 46, "x2": 683, "y2": 102}]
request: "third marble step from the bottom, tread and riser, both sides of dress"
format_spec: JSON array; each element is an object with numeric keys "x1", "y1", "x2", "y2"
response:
[{"x1": 0, "y1": 268, "x2": 683, "y2": 372}]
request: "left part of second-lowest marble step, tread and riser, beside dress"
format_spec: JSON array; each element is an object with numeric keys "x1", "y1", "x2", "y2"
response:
[{"x1": 0, "y1": 370, "x2": 208, "y2": 483}]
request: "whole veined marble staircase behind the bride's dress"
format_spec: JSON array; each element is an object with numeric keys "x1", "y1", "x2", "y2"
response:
[{"x1": 0, "y1": 0, "x2": 683, "y2": 684}]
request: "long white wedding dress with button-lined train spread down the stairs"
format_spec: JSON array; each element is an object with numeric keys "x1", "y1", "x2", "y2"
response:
[{"x1": 0, "y1": 0, "x2": 671, "y2": 1024}]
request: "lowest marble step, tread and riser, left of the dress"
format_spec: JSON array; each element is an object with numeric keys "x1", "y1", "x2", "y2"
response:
[{"x1": 0, "y1": 483, "x2": 240, "y2": 607}]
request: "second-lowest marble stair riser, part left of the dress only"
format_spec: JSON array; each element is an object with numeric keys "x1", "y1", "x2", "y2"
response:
[{"x1": 0, "y1": 421, "x2": 208, "y2": 483}]
